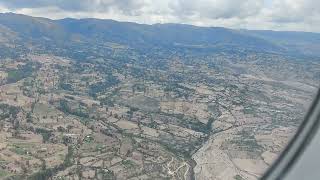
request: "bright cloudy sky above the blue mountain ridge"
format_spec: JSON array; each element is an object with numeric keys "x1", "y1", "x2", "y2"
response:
[{"x1": 0, "y1": 0, "x2": 320, "y2": 32}]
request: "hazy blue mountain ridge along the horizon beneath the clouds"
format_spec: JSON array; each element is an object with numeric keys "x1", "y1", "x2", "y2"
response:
[{"x1": 0, "y1": 13, "x2": 320, "y2": 57}]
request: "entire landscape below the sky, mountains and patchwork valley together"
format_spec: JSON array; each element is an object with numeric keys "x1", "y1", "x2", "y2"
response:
[{"x1": 0, "y1": 13, "x2": 320, "y2": 180}]
